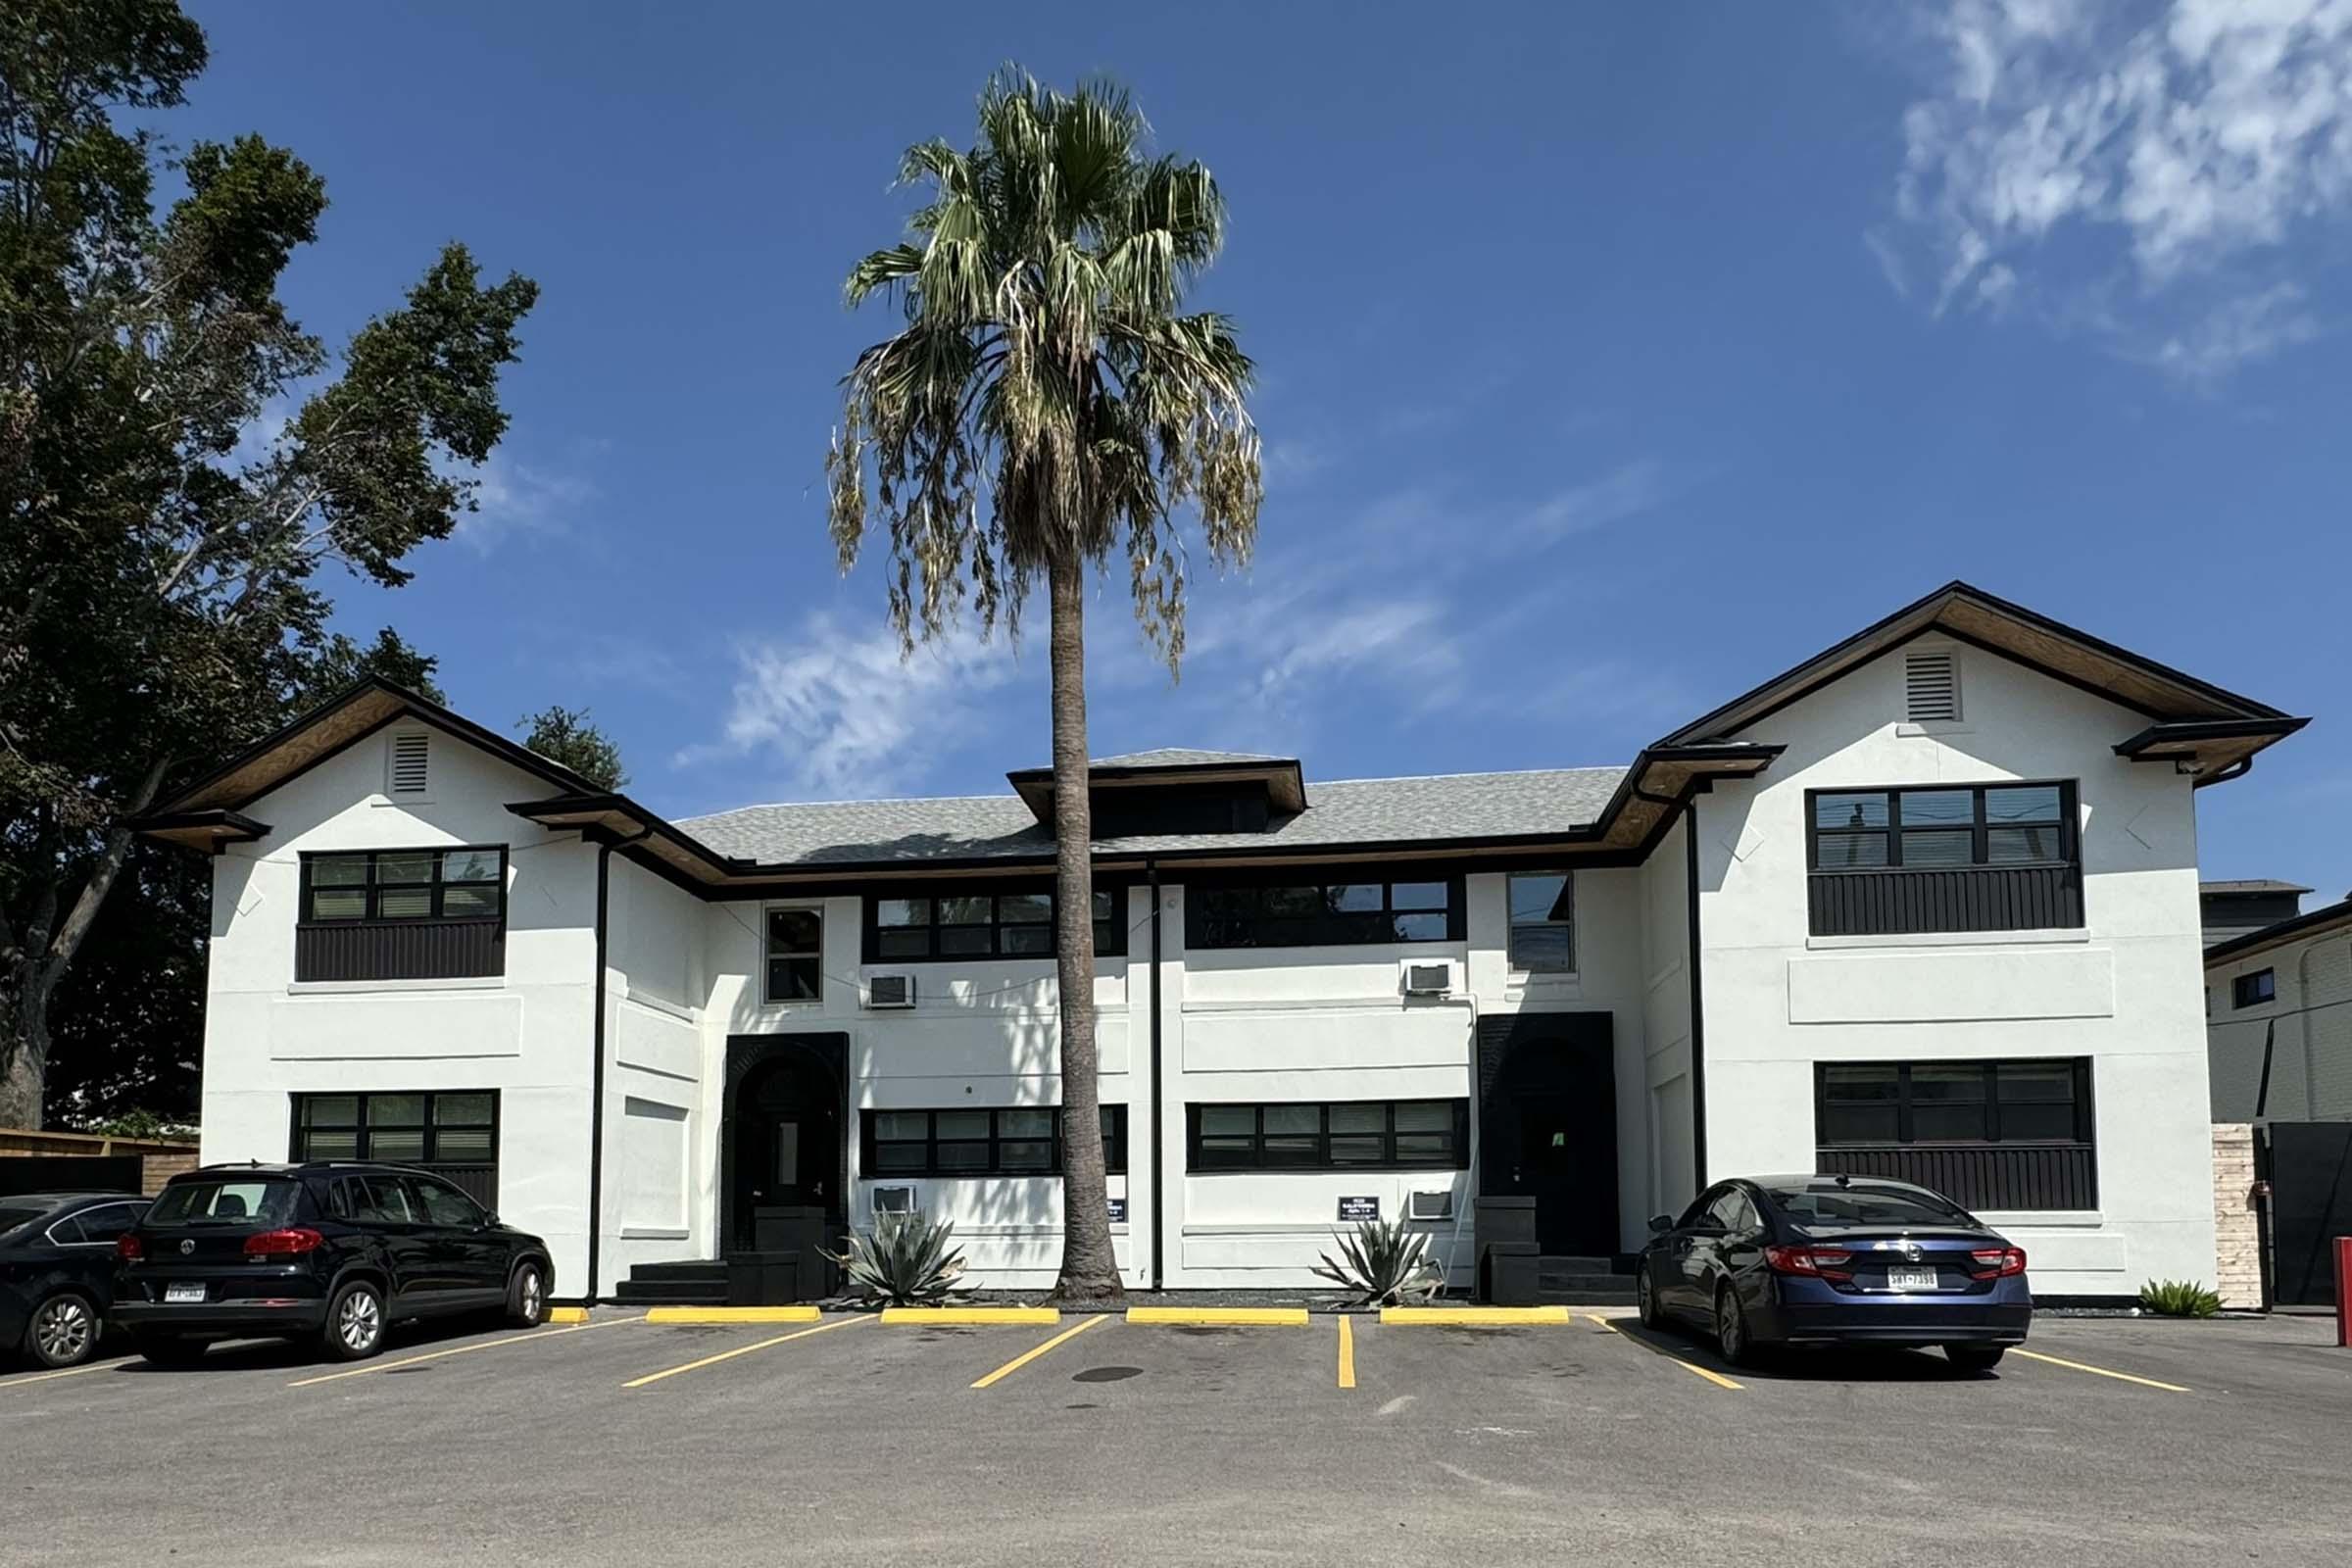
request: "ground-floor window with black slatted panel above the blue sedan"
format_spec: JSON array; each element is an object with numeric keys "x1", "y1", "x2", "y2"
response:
[{"x1": 1813, "y1": 1055, "x2": 2098, "y2": 1208}]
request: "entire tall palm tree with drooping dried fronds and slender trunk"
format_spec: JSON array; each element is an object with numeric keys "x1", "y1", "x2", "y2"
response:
[{"x1": 825, "y1": 69, "x2": 1263, "y2": 1300}]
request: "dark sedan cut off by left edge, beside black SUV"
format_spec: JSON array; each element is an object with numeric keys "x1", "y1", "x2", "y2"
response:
[{"x1": 0, "y1": 1192, "x2": 148, "y2": 1366}]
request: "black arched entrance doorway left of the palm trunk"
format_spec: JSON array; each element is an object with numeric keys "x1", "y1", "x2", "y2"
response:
[{"x1": 719, "y1": 1034, "x2": 849, "y2": 1300}]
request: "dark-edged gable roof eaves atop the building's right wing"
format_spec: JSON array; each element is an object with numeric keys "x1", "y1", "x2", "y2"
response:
[{"x1": 1660, "y1": 581, "x2": 2310, "y2": 783}]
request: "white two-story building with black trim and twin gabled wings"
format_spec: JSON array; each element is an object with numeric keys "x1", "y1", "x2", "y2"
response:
[{"x1": 141, "y1": 583, "x2": 2303, "y2": 1298}]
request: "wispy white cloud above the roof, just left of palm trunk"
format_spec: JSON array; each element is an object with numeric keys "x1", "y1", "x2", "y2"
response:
[{"x1": 675, "y1": 615, "x2": 1018, "y2": 800}]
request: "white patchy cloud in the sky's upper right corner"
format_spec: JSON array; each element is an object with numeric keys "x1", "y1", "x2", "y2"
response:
[{"x1": 1865, "y1": 0, "x2": 2352, "y2": 367}]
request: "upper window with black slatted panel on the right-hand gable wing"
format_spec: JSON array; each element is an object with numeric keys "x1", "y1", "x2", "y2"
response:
[{"x1": 1806, "y1": 780, "x2": 2082, "y2": 936}]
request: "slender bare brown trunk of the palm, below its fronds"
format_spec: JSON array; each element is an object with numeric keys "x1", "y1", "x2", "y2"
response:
[{"x1": 1047, "y1": 553, "x2": 1119, "y2": 1302}]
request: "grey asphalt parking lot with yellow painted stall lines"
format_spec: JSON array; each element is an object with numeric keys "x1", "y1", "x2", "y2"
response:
[{"x1": 0, "y1": 1309, "x2": 2352, "y2": 1568}]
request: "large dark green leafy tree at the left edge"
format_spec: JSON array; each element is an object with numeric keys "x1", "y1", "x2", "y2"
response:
[{"x1": 0, "y1": 0, "x2": 536, "y2": 1126}]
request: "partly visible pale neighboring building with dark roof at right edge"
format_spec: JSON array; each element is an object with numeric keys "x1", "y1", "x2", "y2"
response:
[{"x1": 2204, "y1": 898, "x2": 2352, "y2": 1121}]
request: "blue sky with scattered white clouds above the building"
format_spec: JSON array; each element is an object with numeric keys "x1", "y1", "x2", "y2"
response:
[{"x1": 183, "y1": 0, "x2": 2352, "y2": 898}]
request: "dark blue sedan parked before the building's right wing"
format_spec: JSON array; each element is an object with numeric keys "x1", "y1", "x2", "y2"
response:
[{"x1": 1635, "y1": 1175, "x2": 2034, "y2": 1371}]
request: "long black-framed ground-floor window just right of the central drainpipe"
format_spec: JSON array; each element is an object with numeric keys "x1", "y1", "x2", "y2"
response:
[{"x1": 1186, "y1": 1101, "x2": 1470, "y2": 1171}]
